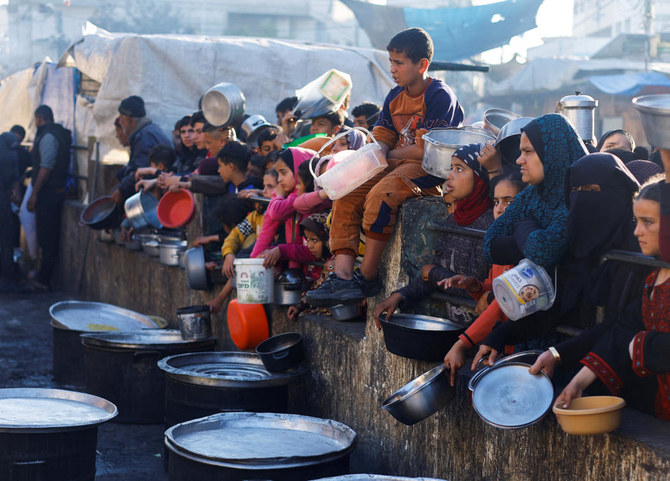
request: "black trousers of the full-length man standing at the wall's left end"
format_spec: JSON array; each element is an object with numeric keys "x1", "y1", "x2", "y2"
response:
[{"x1": 35, "y1": 190, "x2": 65, "y2": 285}]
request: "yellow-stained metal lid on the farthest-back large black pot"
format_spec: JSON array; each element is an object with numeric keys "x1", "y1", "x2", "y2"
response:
[{"x1": 49, "y1": 301, "x2": 158, "y2": 332}]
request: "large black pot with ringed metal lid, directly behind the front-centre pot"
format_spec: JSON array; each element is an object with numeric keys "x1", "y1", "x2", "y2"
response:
[{"x1": 158, "y1": 352, "x2": 306, "y2": 426}]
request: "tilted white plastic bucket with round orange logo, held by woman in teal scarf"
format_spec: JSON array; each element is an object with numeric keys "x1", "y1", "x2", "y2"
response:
[{"x1": 493, "y1": 259, "x2": 556, "y2": 321}]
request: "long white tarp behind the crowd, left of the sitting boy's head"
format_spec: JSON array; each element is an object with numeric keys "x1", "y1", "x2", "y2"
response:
[{"x1": 61, "y1": 24, "x2": 394, "y2": 162}]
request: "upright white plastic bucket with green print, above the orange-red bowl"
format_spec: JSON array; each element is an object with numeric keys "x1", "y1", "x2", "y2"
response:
[{"x1": 233, "y1": 258, "x2": 274, "y2": 304}]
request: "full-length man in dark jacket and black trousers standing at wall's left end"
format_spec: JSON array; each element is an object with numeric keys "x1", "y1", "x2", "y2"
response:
[{"x1": 27, "y1": 105, "x2": 72, "y2": 291}]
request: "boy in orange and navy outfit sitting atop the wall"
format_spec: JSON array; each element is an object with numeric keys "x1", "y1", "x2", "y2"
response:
[{"x1": 307, "y1": 28, "x2": 463, "y2": 307}]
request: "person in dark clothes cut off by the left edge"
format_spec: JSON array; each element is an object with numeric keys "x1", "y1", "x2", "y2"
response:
[{"x1": 0, "y1": 132, "x2": 19, "y2": 292}]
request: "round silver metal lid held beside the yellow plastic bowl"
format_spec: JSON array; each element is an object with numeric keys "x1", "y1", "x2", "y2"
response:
[{"x1": 472, "y1": 362, "x2": 554, "y2": 429}]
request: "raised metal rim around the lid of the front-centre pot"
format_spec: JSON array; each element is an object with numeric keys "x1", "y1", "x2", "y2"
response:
[{"x1": 164, "y1": 412, "x2": 358, "y2": 470}]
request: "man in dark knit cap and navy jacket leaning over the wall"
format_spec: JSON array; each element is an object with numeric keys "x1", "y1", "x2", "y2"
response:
[{"x1": 112, "y1": 95, "x2": 172, "y2": 203}]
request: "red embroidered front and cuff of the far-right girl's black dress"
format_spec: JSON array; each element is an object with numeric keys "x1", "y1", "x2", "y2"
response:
[{"x1": 633, "y1": 270, "x2": 670, "y2": 421}]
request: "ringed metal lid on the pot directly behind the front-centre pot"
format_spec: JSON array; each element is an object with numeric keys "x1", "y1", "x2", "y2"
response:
[{"x1": 158, "y1": 351, "x2": 306, "y2": 388}]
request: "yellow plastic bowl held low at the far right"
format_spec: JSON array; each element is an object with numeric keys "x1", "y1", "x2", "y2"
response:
[{"x1": 553, "y1": 396, "x2": 626, "y2": 435}]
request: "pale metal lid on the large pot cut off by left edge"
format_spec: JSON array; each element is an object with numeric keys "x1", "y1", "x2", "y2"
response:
[{"x1": 0, "y1": 388, "x2": 118, "y2": 432}]
